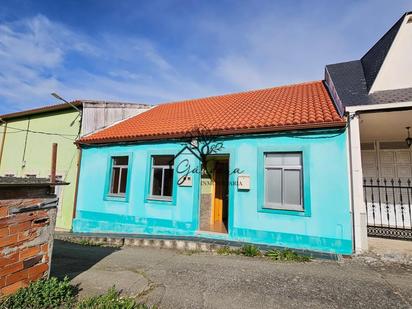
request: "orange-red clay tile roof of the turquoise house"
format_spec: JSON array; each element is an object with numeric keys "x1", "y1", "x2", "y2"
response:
[{"x1": 79, "y1": 81, "x2": 345, "y2": 143}]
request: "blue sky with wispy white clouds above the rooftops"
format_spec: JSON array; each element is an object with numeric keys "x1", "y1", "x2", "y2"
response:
[{"x1": 0, "y1": 0, "x2": 412, "y2": 114}]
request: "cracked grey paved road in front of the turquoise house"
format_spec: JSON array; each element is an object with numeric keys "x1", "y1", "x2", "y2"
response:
[{"x1": 52, "y1": 241, "x2": 412, "y2": 308}]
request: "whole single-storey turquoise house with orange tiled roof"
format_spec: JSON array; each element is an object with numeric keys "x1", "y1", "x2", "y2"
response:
[{"x1": 73, "y1": 81, "x2": 352, "y2": 254}]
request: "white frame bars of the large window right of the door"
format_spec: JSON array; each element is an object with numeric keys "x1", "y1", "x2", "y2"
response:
[{"x1": 263, "y1": 152, "x2": 304, "y2": 211}]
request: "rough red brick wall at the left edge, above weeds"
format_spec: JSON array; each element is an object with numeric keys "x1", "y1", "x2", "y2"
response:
[{"x1": 0, "y1": 199, "x2": 56, "y2": 296}]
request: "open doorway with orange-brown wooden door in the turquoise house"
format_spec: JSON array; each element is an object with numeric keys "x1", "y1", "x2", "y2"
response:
[{"x1": 213, "y1": 162, "x2": 229, "y2": 222}]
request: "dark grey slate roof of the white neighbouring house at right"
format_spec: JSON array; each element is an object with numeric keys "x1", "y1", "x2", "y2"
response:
[{"x1": 325, "y1": 12, "x2": 412, "y2": 114}]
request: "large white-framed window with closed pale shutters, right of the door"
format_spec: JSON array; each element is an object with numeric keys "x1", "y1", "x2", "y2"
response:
[{"x1": 264, "y1": 152, "x2": 303, "y2": 211}]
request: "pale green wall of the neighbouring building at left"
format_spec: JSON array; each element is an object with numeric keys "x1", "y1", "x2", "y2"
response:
[{"x1": 0, "y1": 109, "x2": 80, "y2": 229}]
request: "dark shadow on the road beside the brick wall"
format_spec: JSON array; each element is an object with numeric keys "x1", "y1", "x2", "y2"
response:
[{"x1": 51, "y1": 240, "x2": 119, "y2": 279}]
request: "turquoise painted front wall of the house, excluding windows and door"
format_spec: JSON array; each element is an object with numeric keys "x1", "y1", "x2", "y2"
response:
[{"x1": 73, "y1": 132, "x2": 352, "y2": 254}]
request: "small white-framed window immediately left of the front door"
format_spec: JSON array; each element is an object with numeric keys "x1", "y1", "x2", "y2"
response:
[{"x1": 150, "y1": 156, "x2": 174, "y2": 200}]
